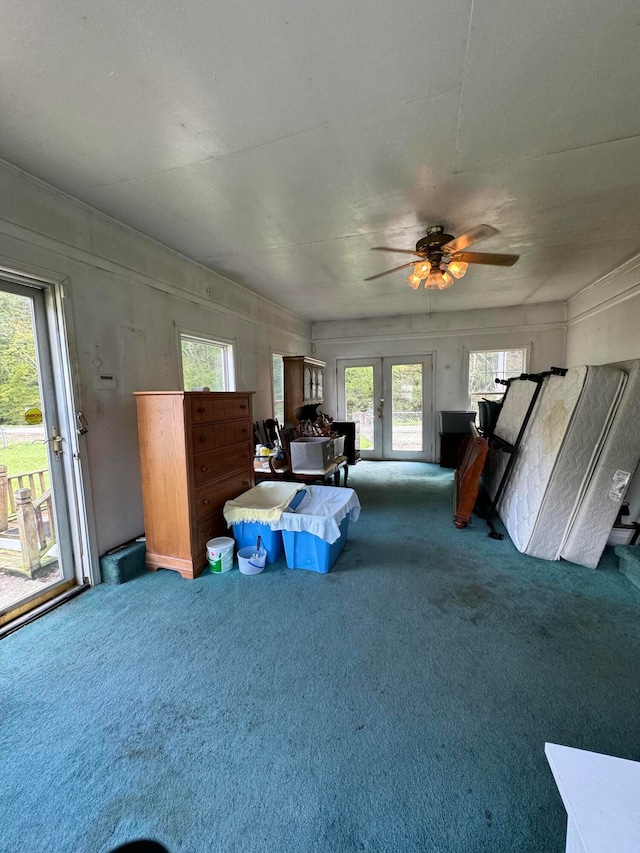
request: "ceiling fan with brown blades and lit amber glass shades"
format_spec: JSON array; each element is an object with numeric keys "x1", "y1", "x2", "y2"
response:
[{"x1": 365, "y1": 225, "x2": 520, "y2": 290}]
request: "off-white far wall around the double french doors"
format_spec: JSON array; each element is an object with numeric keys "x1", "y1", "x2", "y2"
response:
[{"x1": 313, "y1": 302, "x2": 566, "y2": 456}]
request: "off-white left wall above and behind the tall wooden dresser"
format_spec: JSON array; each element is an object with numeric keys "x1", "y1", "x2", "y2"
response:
[{"x1": 0, "y1": 163, "x2": 311, "y2": 553}]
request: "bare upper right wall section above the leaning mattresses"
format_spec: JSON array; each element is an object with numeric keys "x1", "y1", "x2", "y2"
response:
[{"x1": 567, "y1": 256, "x2": 640, "y2": 366}]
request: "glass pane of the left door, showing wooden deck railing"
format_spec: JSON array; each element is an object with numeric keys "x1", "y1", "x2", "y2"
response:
[{"x1": 0, "y1": 291, "x2": 62, "y2": 612}]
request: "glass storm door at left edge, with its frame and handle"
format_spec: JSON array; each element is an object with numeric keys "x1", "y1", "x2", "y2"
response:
[{"x1": 0, "y1": 281, "x2": 76, "y2": 625}]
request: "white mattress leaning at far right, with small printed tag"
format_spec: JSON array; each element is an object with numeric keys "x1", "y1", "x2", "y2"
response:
[{"x1": 560, "y1": 361, "x2": 640, "y2": 569}]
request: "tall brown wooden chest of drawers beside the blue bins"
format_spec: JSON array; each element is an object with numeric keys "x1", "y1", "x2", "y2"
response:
[{"x1": 135, "y1": 391, "x2": 255, "y2": 578}]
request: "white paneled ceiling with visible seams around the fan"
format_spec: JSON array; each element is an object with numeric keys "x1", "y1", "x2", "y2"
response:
[{"x1": 0, "y1": 0, "x2": 640, "y2": 320}]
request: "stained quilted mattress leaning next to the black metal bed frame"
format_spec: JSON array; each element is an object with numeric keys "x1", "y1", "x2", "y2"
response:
[{"x1": 497, "y1": 366, "x2": 626, "y2": 560}]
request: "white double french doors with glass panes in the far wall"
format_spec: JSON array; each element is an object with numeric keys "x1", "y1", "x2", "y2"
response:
[{"x1": 337, "y1": 355, "x2": 434, "y2": 462}]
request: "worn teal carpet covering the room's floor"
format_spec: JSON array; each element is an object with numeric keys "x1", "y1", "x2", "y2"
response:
[{"x1": 0, "y1": 463, "x2": 640, "y2": 853}]
